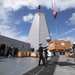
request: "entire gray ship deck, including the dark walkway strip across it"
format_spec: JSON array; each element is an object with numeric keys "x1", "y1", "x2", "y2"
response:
[{"x1": 0, "y1": 55, "x2": 75, "y2": 75}]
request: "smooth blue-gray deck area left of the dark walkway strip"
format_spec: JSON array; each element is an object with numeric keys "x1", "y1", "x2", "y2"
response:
[{"x1": 0, "y1": 57, "x2": 38, "y2": 75}]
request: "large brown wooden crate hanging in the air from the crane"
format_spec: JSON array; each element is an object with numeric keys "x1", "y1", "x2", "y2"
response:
[{"x1": 48, "y1": 40, "x2": 71, "y2": 51}]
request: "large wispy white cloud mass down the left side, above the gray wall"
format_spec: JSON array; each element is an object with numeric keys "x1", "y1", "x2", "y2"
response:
[{"x1": 0, "y1": 0, "x2": 27, "y2": 42}]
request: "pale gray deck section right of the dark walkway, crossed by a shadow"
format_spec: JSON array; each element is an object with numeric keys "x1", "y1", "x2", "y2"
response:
[{"x1": 54, "y1": 56, "x2": 75, "y2": 75}]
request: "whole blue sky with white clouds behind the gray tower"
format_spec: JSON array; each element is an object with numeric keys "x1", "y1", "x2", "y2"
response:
[{"x1": 0, "y1": 0, "x2": 75, "y2": 42}]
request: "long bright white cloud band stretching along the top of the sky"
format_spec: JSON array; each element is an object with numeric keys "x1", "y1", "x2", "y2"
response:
[{"x1": 2, "y1": 0, "x2": 75, "y2": 11}]
